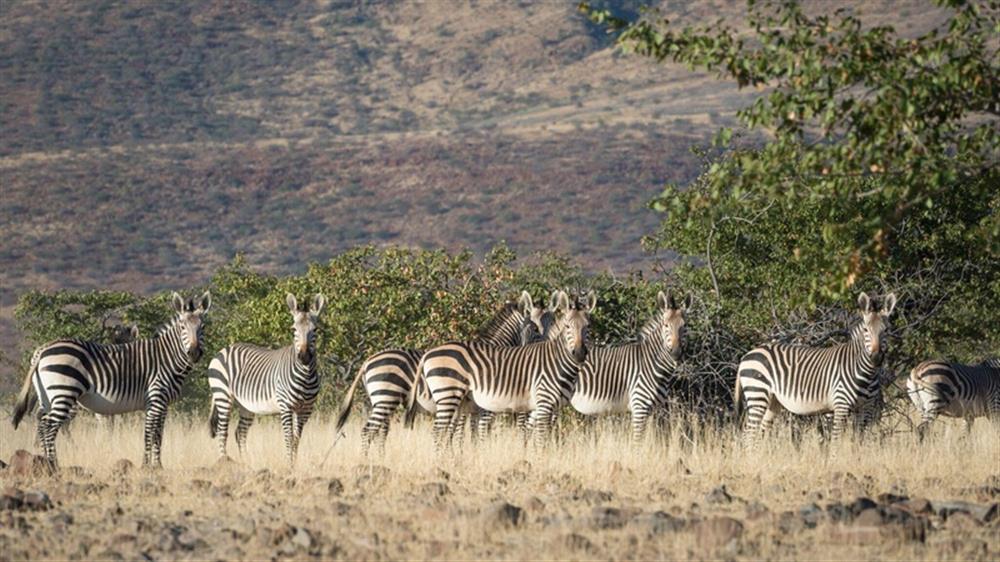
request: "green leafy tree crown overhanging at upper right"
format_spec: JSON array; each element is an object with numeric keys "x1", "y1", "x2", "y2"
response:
[{"x1": 581, "y1": 0, "x2": 1000, "y2": 298}]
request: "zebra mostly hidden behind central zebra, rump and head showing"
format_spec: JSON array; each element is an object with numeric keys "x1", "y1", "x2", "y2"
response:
[{"x1": 337, "y1": 291, "x2": 554, "y2": 454}]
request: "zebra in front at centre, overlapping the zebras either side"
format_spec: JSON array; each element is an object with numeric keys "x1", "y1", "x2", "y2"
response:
[{"x1": 407, "y1": 291, "x2": 597, "y2": 450}]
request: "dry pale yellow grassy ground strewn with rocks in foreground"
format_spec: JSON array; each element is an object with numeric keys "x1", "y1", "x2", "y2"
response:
[{"x1": 0, "y1": 410, "x2": 1000, "y2": 560}]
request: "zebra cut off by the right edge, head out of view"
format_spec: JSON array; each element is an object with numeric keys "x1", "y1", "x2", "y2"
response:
[{"x1": 906, "y1": 358, "x2": 1000, "y2": 440}]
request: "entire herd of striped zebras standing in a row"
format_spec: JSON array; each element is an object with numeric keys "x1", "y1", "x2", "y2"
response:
[{"x1": 12, "y1": 291, "x2": 1000, "y2": 468}]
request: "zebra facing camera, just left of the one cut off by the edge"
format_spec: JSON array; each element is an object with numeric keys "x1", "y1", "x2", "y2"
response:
[{"x1": 733, "y1": 293, "x2": 896, "y2": 440}]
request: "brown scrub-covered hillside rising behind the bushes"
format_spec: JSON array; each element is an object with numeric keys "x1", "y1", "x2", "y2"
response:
[{"x1": 0, "y1": 0, "x2": 933, "y2": 360}]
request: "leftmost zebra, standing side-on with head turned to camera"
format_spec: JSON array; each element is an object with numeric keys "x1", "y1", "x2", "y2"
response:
[{"x1": 12, "y1": 291, "x2": 212, "y2": 469}]
